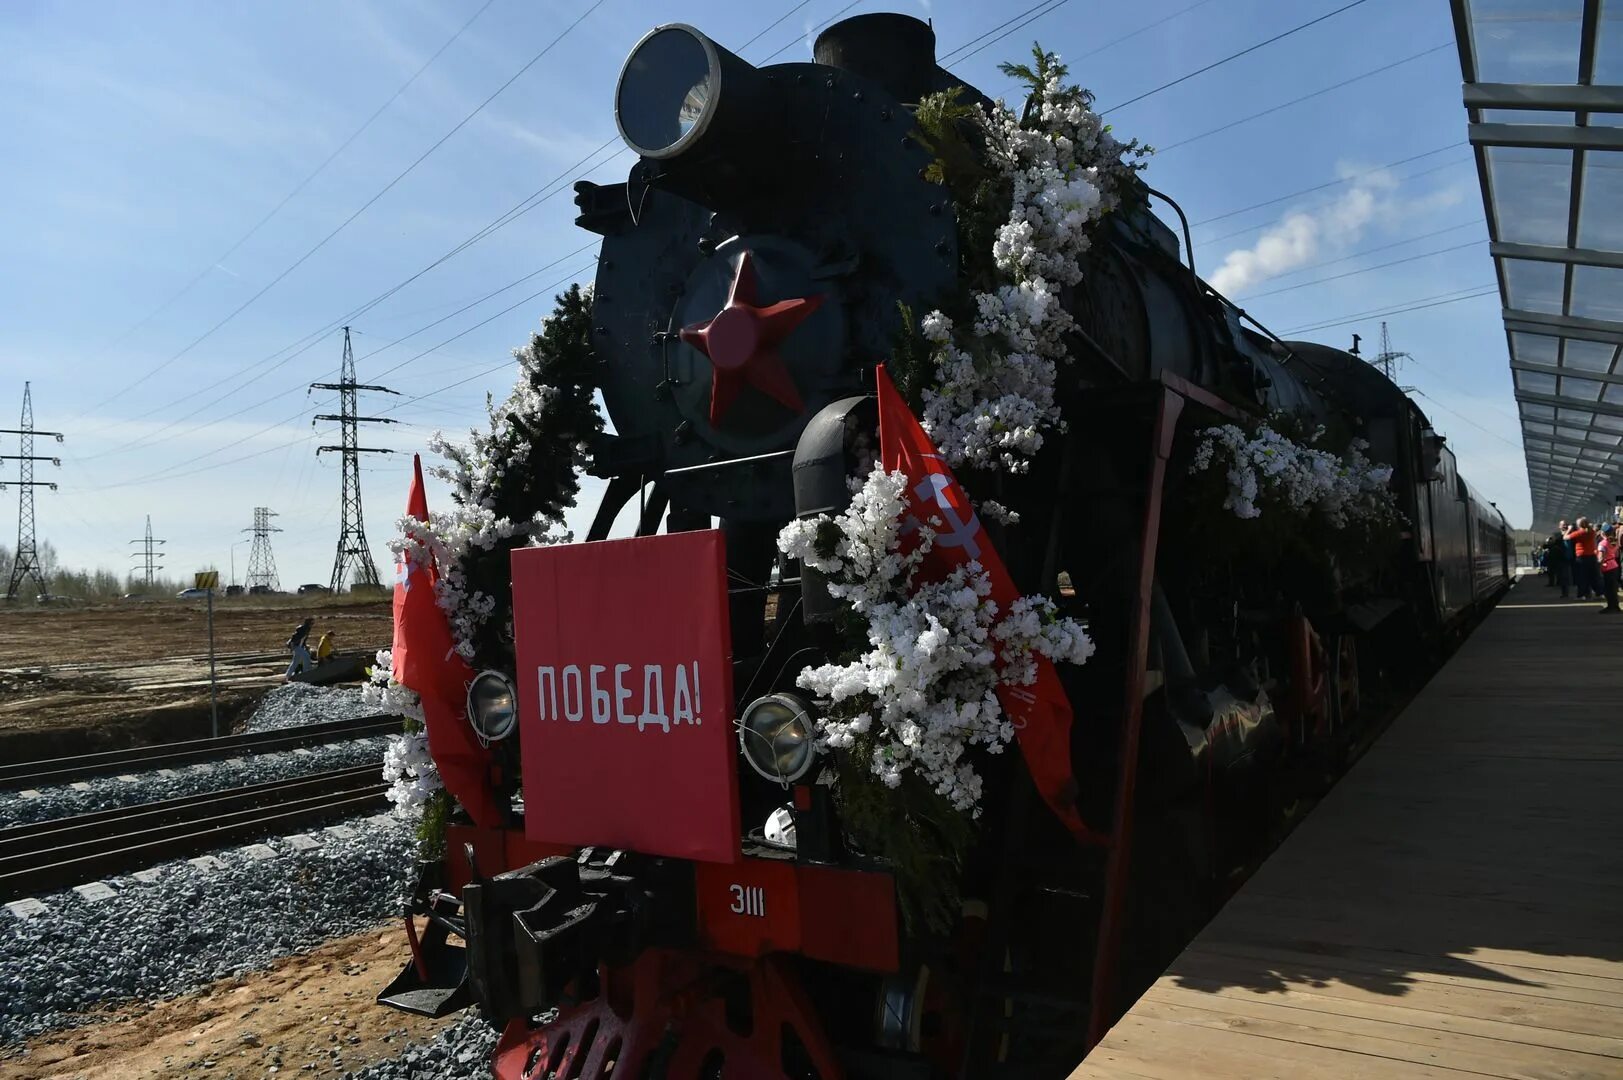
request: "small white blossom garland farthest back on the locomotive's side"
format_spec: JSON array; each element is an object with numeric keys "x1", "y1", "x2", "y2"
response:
[{"x1": 1190, "y1": 424, "x2": 1399, "y2": 529}]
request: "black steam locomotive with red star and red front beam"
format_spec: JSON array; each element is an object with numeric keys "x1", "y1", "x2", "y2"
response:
[{"x1": 381, "y1": 15, "x2": 1511, "y2": 1080}]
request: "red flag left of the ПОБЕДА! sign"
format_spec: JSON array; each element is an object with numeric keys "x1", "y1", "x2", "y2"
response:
[{"x1": 393, "y1": 455, "x2": 503, "y2": 828}]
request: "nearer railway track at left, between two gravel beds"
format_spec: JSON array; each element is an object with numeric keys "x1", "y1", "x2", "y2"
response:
[{"x1": 0, "y1": 763, "x2": 386, "y2": 901}]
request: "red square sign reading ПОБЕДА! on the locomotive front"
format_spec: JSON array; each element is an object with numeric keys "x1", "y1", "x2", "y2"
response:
[{"x1": 513, "y1": 531, "x2": 738, "y2": 862}]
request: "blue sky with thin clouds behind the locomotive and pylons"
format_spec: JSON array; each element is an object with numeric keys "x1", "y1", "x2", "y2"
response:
[{"x1": 0, "y1": 0, "x2": 1530, "y2": 588}]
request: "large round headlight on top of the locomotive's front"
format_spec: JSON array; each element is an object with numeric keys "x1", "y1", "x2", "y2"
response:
[{"x1": 615, "y1": 23, "x2": 764, "y2": 161}]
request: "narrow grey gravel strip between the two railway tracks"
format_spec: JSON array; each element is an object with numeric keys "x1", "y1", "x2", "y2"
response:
[{"x1": 0, "y1": 736, "x2": 388, "y2": 828}]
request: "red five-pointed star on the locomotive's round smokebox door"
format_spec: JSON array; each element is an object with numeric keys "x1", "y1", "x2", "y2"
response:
[{"x1": 682, "y1": 252, "x2": 823, "y2": 427}]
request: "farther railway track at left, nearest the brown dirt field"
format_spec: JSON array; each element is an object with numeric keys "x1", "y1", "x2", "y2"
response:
[{"x1": 0, "y1": 715, "x2": 401, "y2": 791}]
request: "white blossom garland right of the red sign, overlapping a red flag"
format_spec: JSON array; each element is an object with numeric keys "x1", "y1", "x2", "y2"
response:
[{"x1": 777, "y1": 468, "x2": 1094, "y2": 815}]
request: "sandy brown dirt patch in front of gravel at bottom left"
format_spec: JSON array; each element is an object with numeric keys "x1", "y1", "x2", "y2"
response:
[{"x1": 0, "y1": 922, "x2": 450, "y2": 1080}]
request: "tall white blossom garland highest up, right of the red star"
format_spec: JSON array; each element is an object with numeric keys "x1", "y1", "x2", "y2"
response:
[{"x1": 919, "y1": 76, "x2": 1131, "y2": 473}]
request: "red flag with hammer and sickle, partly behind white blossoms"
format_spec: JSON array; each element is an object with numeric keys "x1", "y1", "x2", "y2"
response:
[{"x1": 875, "y1": 364, "x2": 1099, "y2": 840}]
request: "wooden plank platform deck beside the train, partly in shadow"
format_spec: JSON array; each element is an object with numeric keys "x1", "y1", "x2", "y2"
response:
[{"x1": 1073, "y1": 578, "x2": 1623, "y2": 1080}]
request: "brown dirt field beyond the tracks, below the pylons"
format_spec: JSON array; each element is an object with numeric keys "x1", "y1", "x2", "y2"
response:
[{"x1": 0, "y1": 596, "x2": 393, "y2": 760}]
